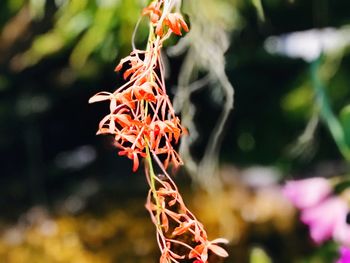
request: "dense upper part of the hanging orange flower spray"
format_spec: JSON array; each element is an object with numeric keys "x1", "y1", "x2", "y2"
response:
[{"x1": 89, "y1": 0, "x2": 188, "y2": 171}]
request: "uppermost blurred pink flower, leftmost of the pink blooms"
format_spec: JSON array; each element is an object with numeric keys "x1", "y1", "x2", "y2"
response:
[{"x1": 283, "y1": 177, "x2": 332, "y2": 209}]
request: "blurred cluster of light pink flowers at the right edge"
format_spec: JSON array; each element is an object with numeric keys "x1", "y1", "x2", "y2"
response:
[{"x1": 284, "y1": 178, "x2": 350, "y2": 248}]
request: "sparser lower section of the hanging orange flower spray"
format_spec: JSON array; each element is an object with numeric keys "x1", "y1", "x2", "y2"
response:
[{"x1": 146, "y1": 168, "x2": 228, "y2": 263}]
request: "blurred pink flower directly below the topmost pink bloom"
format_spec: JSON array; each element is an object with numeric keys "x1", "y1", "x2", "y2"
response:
[{"x1": 301, "y1": 197, "x2": 348, "y2": 244}]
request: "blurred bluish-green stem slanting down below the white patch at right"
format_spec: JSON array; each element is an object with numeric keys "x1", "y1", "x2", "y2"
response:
[{"x1": 311, "y1": 56, "x2": 350, "y2": 161}]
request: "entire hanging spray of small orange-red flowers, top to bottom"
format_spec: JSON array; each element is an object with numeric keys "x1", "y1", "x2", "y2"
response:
[{"x1": 89, "y1": 0, "x2": 228, "y2": 263}]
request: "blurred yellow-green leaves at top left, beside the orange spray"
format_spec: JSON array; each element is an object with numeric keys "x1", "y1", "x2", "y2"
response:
[{"x1": 5, "y1": 0, "x2": 141, "y2": 69}]
